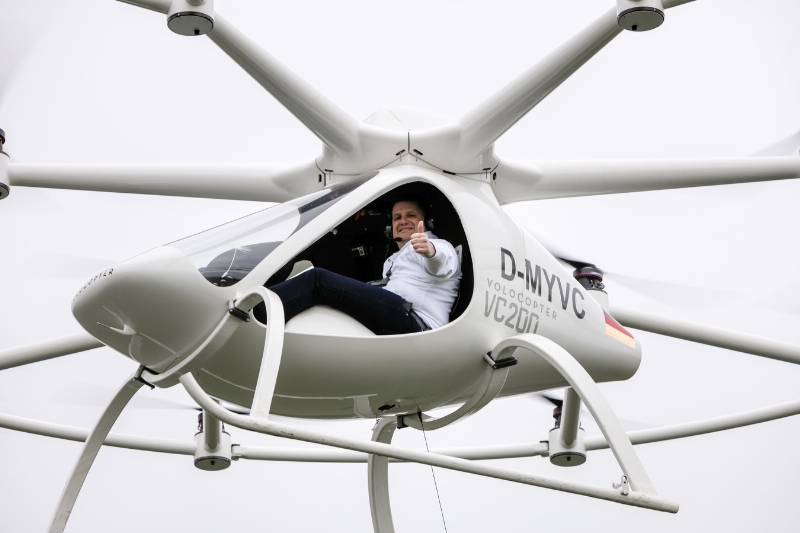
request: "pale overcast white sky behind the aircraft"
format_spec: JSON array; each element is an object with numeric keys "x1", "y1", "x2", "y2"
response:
[{"x1": 0, "y1": 0, "x2": 800, "y2": 533}]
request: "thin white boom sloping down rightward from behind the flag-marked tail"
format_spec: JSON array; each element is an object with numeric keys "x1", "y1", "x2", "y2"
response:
[{"x1": 611, "y1": 305, "x2": 800, "y2": 364}]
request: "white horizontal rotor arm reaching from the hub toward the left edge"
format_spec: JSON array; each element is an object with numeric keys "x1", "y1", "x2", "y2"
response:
[{"x1": 8, "y1": 161, "x2": 322, "y2": 202}]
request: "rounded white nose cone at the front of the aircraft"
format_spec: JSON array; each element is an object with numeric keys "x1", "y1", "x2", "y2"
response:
[{"x1": 72, "y1": 246, "x2": 233, "y2": 372}]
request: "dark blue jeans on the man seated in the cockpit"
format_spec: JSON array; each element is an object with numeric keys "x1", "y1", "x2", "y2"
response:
[{"x1": 260, "y1": 268, "x2": 422, "y2": 335}]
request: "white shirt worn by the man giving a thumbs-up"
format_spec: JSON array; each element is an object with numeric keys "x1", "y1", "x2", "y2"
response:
[{"x1": 383, "y1": 231, "x2": 461, "y2": 329}]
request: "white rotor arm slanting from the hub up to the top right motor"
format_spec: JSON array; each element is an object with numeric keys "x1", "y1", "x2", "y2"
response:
[{"x1": 411, "y1": 0, "x2": 691, "y2": 172}]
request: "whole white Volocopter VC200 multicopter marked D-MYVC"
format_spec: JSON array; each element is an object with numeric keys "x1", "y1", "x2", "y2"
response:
[{"x1": 4, "y1": 3, "x2": 798, "y2": 530}]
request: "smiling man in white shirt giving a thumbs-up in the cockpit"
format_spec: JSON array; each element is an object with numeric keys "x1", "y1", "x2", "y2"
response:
[{"x1": 262, "y1": 195, "x2": 461, "y2": 335}]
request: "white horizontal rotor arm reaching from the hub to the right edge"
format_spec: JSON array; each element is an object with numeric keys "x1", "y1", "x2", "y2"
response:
[{"x1": 494, "y1": 156, "x2": 800, "y2": 204}]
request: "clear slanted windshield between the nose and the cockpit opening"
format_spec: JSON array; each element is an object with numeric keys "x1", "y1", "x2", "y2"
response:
[{"x1": 169, "y1": 172, "x2": 377, "y2": 287}]
